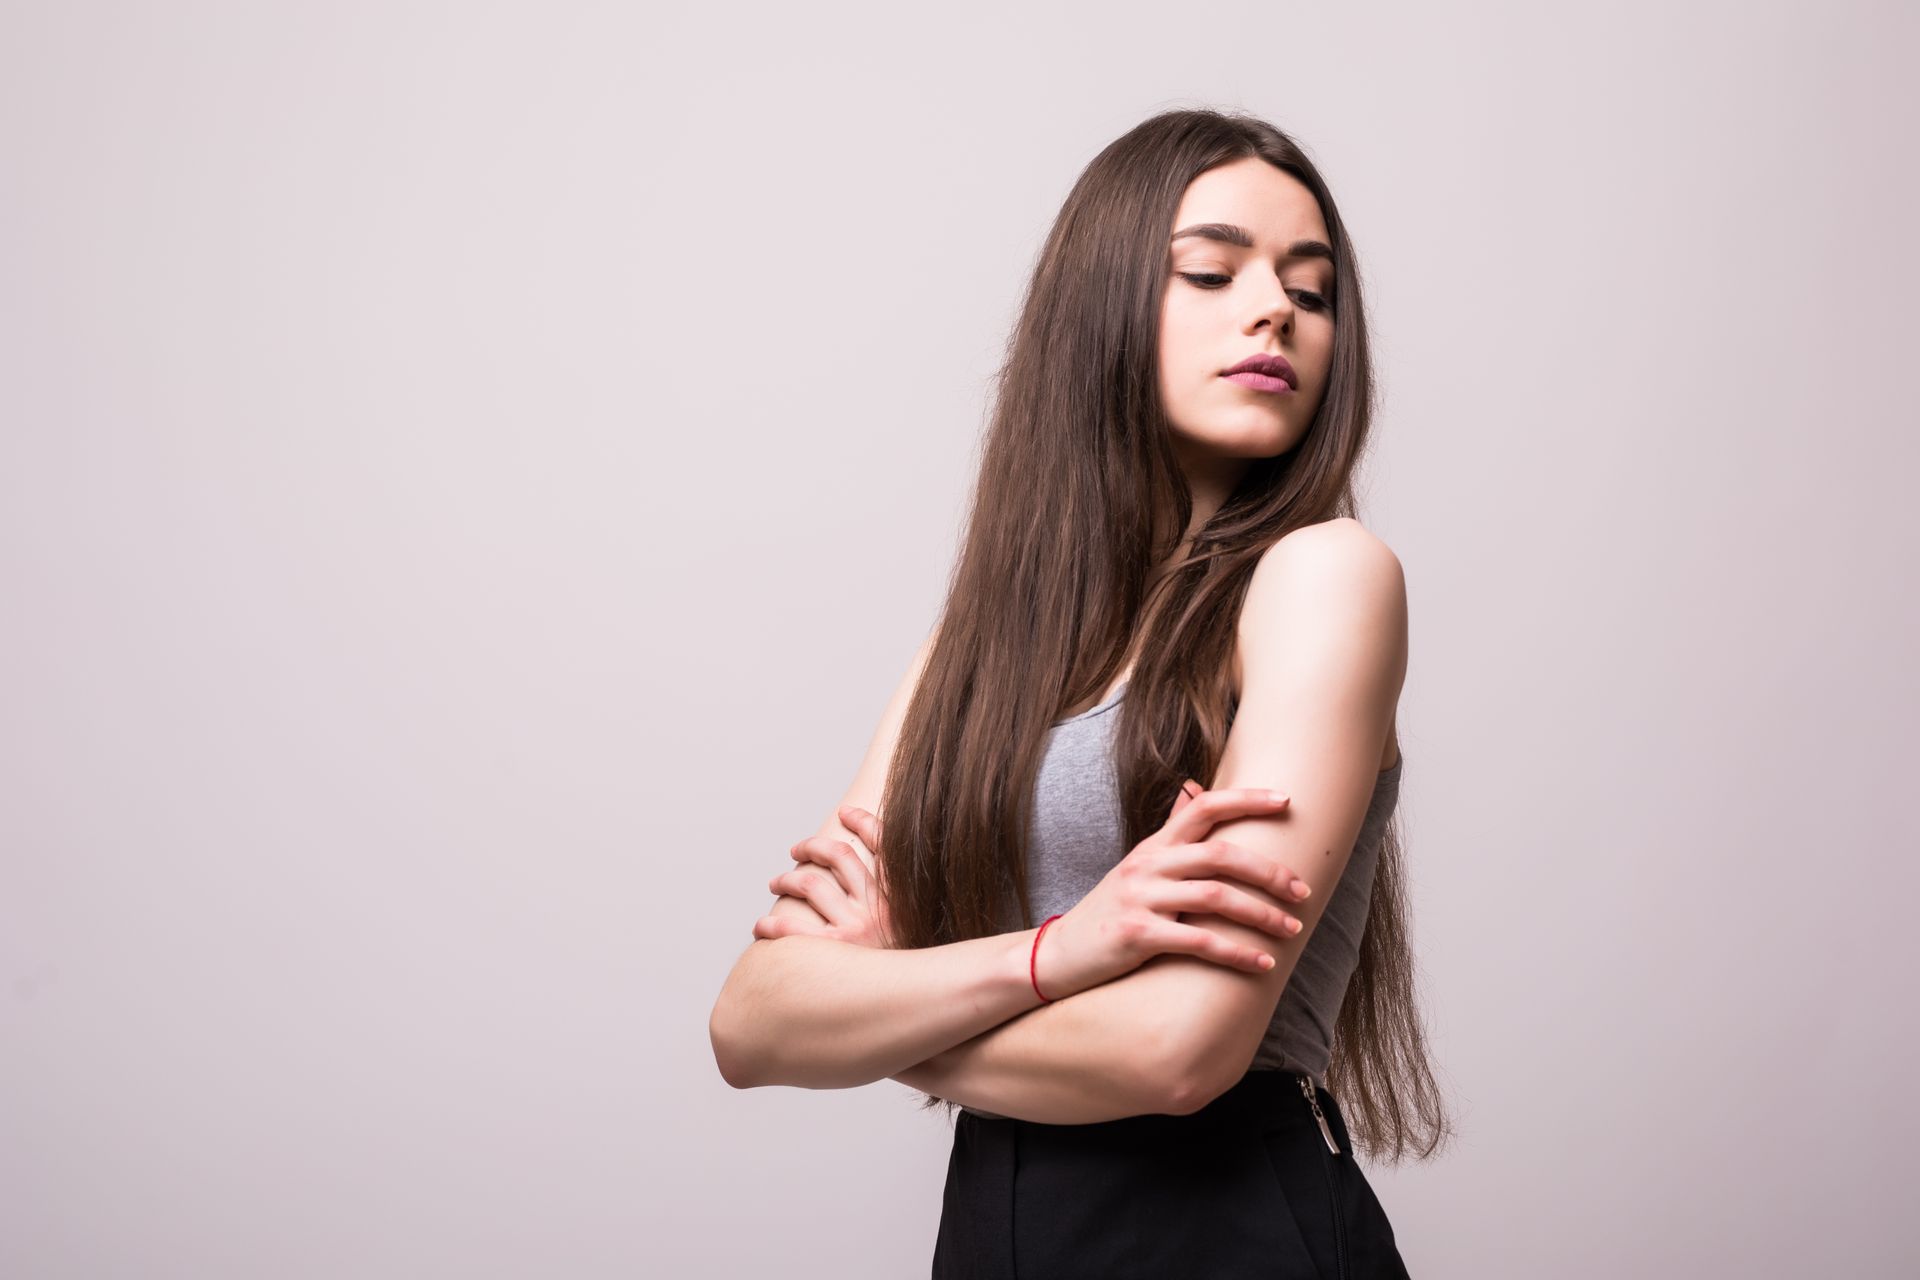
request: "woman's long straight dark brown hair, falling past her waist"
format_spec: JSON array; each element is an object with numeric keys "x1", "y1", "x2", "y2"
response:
[{"x1": 879, "y1": 109, "x2": 1450, "y2": 1163}]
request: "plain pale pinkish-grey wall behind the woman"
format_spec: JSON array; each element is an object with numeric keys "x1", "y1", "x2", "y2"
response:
[{"x1": 0, "y1": 0, "x2": 1920, "y2": 1278}]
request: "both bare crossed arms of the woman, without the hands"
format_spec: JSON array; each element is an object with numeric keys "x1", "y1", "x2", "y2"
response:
[{"x1": 708, "y1": 518, "x2": 1407, "y2": 1125}]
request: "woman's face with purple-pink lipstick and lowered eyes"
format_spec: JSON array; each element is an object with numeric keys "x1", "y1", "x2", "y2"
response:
[{"x1": 1160, "y1": 157, "x2": 1334, "y2": 468}]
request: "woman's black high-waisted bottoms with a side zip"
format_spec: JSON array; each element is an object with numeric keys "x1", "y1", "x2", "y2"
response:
[{"x1": 933, "y1": 1071, "x2": 1407, "y2": 1280}]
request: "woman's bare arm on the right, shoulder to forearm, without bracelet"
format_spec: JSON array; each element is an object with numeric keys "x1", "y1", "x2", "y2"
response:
[{"x1": 893, "y1": 520, "x2": 1407, "y2": 1125}]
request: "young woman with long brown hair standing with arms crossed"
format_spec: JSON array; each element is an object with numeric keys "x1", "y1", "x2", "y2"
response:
[{"x1": 710, "y1": 111, "x2": 1450, "y2": 1280}]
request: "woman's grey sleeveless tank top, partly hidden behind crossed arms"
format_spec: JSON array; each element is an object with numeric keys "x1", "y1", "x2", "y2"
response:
[{"x1": 962, "y1": 683, "x2": 1407, "y2": 1119}]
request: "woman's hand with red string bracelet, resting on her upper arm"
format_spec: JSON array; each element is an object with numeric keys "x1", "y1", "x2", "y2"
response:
[{"x1": 1033, "y1": 781, "x2": 1308, "y2": 1000}]
